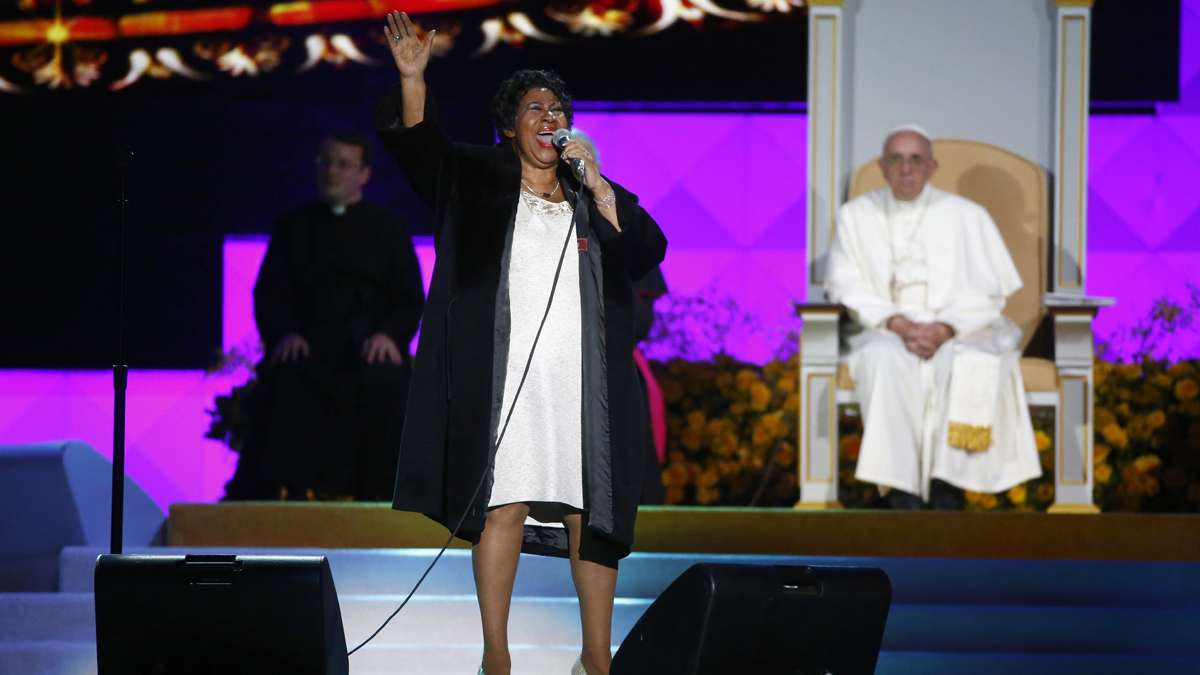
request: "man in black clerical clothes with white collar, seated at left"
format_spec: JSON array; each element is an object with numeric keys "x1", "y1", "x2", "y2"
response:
[{"x1": 227, "y1": 133, "x2": 425, "y2": 501}]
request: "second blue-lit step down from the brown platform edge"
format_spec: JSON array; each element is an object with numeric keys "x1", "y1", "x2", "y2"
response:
[{"x1": 0, "y1": 583, "x2": 1200, "y2": 655}]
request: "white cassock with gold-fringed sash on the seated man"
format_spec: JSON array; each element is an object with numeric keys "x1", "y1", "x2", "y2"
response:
[{"x1": 826, "y1": 185, "x2": 1042, "y2": 500}]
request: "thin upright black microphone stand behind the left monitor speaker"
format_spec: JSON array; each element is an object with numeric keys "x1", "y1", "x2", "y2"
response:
[{"x1": 110, "y1": 148, "x2": 133, "y2": 555}]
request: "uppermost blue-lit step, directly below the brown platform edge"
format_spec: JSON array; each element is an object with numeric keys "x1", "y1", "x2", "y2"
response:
[{"x1": 51, "y1": 548, "x2": 1200, "y2": 608}]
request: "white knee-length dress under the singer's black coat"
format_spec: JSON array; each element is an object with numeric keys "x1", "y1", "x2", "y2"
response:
[{"x1": 488, "y1": 191, "x2": 583, "y2": 524}]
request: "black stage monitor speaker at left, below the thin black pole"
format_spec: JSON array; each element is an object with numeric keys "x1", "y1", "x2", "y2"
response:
[{"x1": 96, "y1": 555, "x2": 349, "y2": 675}]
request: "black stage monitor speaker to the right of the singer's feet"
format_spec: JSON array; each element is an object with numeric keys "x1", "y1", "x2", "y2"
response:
[{"x1": 612, "y1": 563, "x2": 892, "y2": 675}]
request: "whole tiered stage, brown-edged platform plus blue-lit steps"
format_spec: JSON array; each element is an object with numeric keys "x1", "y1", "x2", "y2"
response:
[{"x1": 0, "y1": 502, "x2": 1200, "y2": 675}]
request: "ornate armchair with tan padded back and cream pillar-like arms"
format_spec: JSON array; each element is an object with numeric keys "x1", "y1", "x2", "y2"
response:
[{"x1": 797, "y1": 141, "x2": 1108, "y2": 513}]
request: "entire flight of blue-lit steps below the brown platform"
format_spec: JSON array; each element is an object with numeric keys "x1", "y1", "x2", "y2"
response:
[{"x1": 0, "y1": 548, "x2": 1200, "y2": 675}]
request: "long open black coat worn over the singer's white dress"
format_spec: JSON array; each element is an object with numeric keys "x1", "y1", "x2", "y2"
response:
[{"x1": 376, "y1": 86, "x2": 666, "y2": 555}]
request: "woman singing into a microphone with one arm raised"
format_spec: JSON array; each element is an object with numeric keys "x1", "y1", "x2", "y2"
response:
[{"x1": 376, "y1": 13, "x2": 666, "y2": 675}]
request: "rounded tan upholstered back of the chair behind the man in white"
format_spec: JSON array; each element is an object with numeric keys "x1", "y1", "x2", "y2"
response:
[{"x1": 848, "y1": 139, "x2": 1050, "y2": 351}]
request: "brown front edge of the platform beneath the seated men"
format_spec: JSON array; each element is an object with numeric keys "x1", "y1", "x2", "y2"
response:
[{"x1": 167, "y1": 502, "x2": 1200, "y2": 561}]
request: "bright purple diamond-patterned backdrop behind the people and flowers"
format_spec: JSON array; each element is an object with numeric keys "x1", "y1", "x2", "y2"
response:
[{"x1": 0, "y1": 0, "x2": 1200, "y2": 507}]
